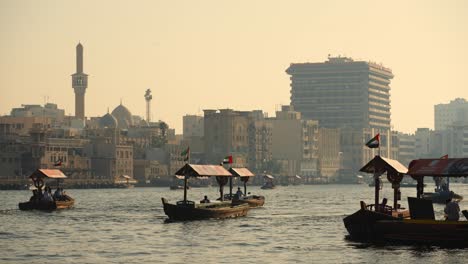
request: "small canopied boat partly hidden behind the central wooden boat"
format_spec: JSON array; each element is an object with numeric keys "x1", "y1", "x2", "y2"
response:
[{"x1": 227, "y1": 168, "x2": 265, "y2": 208}]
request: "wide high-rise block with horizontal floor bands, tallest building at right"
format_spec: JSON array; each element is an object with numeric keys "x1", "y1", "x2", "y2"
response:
[{"x1": 286, "y1": 57, "x2": 393, "y2": 129}]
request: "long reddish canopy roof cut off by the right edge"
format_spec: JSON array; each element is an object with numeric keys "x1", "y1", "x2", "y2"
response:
[{"x1": 408, "y1": 158, "x2": 468, "y2": 177}]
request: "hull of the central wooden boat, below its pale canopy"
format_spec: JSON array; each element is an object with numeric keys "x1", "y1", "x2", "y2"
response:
[{"x1": 162, "y1": 198, "x2": 250, "y2": 221}]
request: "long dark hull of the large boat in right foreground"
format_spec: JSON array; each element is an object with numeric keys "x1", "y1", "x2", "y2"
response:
[{"x1": 343, "y1": 210, "x2": 468, "y2": 247}]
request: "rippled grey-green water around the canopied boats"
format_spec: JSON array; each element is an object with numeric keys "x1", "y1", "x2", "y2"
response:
[{"x1": 0, "y1": 184, "x2": 468, "y2": 263}]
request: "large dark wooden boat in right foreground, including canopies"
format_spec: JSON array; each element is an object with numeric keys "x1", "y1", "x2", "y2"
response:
[{"x1": 343, "y1": 156, "x2": 468, "y2": 247}]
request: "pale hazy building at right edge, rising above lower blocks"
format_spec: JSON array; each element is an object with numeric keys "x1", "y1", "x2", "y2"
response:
[{"x1": 434, "y1": 98, "x2": 468, "y2": 131}]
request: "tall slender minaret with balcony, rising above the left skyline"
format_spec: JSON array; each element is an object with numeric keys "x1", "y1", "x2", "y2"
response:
[{"x1": 72, "y1": 43, "x2": 88, "y2": 120}]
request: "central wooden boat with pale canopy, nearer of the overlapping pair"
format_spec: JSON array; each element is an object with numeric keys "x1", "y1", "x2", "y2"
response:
[{"x1": 161, "y1": 163, "x2": 250, "y2": 221}]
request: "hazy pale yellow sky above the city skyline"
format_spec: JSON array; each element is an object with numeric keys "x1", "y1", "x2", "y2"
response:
[{"x1": 0, "y1": 0, "x2": 468, "y2": 133}]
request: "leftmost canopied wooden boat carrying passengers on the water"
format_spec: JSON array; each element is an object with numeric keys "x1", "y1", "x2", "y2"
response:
[{"x1": 18, "y1": 169, "x2": 75, "y2": 211}]
